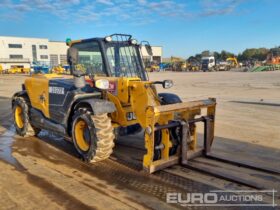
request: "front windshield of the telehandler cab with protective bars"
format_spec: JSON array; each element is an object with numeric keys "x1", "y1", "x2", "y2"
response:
[{"x1": 106, "y1": 43, "x2": 146, "y2": 80}]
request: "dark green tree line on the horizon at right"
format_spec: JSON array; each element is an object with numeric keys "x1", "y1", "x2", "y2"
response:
[{"x1": 188, "y1": 46, "x2": 280, "y2": 62}]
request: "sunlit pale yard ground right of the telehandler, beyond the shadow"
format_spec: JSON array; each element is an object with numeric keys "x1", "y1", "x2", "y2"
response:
[{"x1": 150, "y1": 71, "x2": 280, "y2": 148}]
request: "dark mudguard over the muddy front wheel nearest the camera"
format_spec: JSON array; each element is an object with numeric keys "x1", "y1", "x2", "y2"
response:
[{"x1": 74, "y1": 98, "x2": 116, "y2": 115}]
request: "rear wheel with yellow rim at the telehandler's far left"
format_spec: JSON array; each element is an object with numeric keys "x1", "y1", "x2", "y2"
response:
[{"x1": 12, "y1": 97, "x2": 41, "y2": 137}]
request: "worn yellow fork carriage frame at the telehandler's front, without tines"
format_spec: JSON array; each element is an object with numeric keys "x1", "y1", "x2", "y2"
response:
[{"x1": 143, "y1": 98, "x2": 216, "y2": 173}]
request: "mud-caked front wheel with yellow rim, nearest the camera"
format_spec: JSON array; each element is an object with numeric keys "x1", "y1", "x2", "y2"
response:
[{"x1": 72, "y1": 109, "x2": 115, "y2": 162}]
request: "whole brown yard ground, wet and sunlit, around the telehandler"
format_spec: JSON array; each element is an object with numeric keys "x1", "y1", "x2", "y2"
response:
[{"x1": 0, "y1": 72, "x2": 280, "y2": 209}]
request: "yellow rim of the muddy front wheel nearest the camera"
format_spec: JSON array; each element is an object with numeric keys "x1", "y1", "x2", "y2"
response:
[{"x1": 74, "y1": 120, "x2": 89, "y2": 152}]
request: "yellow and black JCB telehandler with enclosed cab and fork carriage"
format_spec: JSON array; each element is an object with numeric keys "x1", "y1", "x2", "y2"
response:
[{"x1": 12, "y1": 34, "x2": 216, "y2": 173}]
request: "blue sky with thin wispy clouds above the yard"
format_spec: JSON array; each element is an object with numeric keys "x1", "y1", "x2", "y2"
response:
[{"x1": 0, "y1": 0, "x2": 280, "y2": 57}]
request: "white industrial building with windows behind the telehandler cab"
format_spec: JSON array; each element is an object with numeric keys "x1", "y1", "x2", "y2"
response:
[{"x1": 0, "y1": 36, "x2": 162, "y2": 69}]
